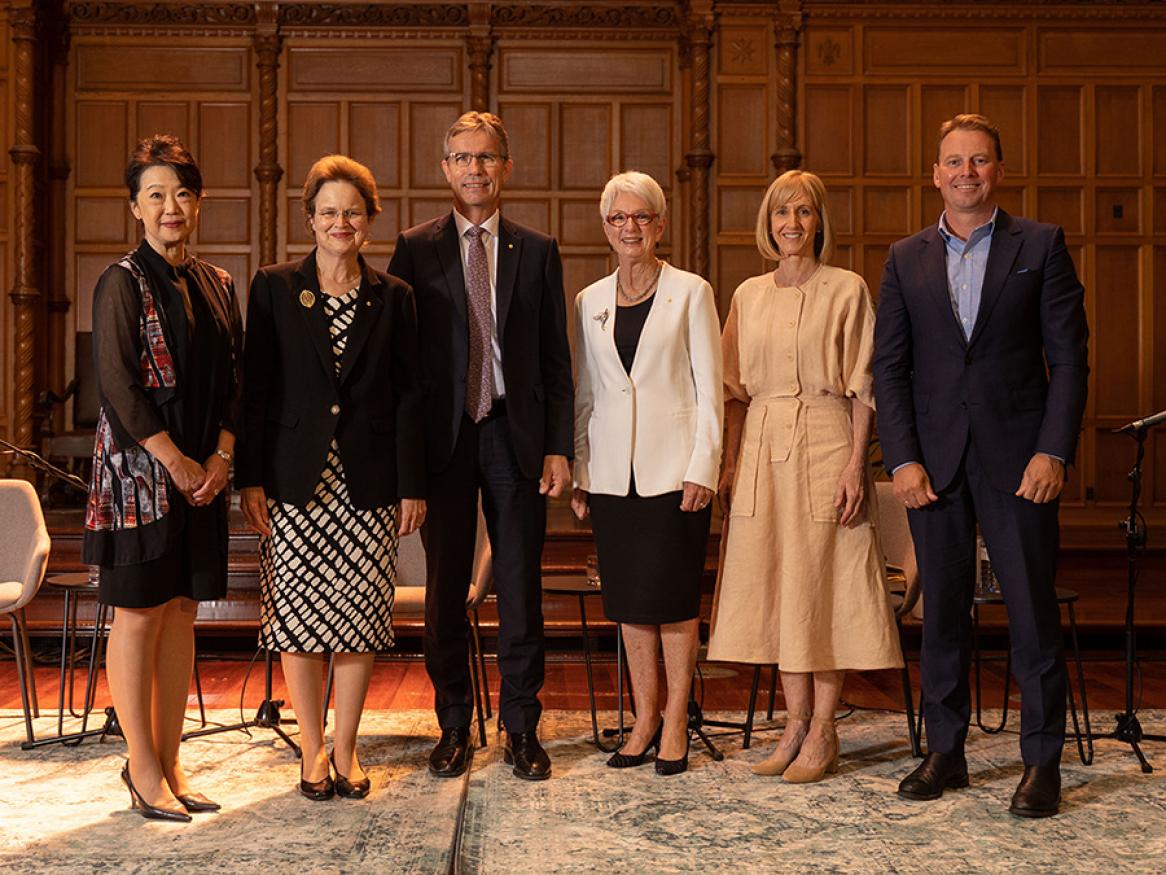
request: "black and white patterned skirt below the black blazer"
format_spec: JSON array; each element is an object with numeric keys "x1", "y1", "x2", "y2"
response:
[{"x1": 259, "y1": 441, "x2": 399, "y2": 653}]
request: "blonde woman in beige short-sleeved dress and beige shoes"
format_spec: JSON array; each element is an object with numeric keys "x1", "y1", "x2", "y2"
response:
[{"x1": 709, "y1": 170, "x2": 902, "y2": 783}]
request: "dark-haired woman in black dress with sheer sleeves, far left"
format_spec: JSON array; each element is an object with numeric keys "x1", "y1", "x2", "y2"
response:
[{"x1": 84, "y1": 134, "x2": 243, "y2": 821}]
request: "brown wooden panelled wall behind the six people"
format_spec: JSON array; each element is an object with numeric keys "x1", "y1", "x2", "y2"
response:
[{"x1": 0, "y1": 0, "x2": 1166, "y2": 545}]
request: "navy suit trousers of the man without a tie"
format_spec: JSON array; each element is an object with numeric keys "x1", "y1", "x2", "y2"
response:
[{"x1": 908, "y1": 440, "x2": 1066, "y2": 765}]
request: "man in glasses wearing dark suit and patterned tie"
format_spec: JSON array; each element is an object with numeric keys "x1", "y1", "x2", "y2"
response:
[{"x1": 388, "y1": 112, "x2": 574, "y2": 781}]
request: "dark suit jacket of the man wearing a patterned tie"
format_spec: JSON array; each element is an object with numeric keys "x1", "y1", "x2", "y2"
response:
[{"x1": 388, "y1": 212, "x2": 575, "y2": 477}]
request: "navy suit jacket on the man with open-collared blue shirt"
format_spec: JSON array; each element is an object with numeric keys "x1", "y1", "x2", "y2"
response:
[{"x1": 873, "y1": 210, "x2": 1089, "y2": 491}]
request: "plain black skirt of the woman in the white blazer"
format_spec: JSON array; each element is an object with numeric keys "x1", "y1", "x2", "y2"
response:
[{"x1": 590, "y1": 483, "x2": 712, "y2": 625}]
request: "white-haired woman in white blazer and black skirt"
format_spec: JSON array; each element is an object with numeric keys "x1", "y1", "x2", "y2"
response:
[{"x1": 571, "y1": 172, "x2": 723, "y2": 775}]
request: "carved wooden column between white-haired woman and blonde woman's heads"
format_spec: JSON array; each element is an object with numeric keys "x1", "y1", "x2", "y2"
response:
[{"x1": 684, "y1": 0, "x2": 714, "y2": 278}]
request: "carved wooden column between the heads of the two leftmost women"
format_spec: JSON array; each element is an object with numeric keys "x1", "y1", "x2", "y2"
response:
[{"x1": 254, "y1": 11, "x2": 283, "y2": 265}]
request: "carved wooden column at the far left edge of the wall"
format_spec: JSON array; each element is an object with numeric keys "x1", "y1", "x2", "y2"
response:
[{"x1": 8, "y1": 2, "x2": 41, "y2": 461}]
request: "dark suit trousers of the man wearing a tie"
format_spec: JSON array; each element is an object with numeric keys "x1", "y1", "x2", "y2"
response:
[{"x1": 421, "y1": 403, "x2": 547, "y2": 733}]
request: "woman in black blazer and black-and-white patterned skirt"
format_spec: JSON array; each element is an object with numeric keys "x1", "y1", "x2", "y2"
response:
[{"x1": 236, "y1": 155, "x2": 426, "y2": 800}]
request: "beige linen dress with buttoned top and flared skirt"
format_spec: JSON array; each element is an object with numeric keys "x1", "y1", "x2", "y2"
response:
[{"x1": 709, "y1": 265, "x2": 902, "y2": 672}]
